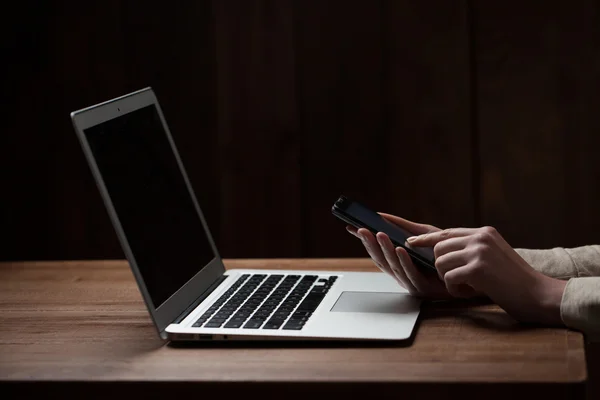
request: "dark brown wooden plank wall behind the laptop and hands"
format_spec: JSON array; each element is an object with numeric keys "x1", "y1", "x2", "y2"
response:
[{"x1": 0, "y1": 0, "x2": 600, "y2": 260}]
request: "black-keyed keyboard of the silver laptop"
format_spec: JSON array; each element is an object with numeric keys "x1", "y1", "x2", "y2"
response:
[{"x1": 192, "y1": 274, "x2": 337, "y2": 330}]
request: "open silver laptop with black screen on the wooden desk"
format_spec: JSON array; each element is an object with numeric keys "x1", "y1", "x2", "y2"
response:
[{"x1": 71, "y1": 88, "x2": 420, "y2": 341}]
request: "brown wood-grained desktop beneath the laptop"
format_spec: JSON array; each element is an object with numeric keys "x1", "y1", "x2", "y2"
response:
[{"x1": 0, "y1": 259, "x2": 586, "y2": 400}]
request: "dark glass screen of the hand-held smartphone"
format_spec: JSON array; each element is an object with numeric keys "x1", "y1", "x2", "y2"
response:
[{"x1": 340, "y1": 199, "x2": 435, "y2": 268}]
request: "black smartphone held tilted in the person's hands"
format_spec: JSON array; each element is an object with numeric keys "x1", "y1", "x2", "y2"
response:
[{"x1": 331, "y1": 196, "x2": 436, "y2": 272}]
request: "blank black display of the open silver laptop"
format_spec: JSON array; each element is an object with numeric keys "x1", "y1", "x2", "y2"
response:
[{"x1": 84, "y1": 105, "x2": 215, "y2": 308}]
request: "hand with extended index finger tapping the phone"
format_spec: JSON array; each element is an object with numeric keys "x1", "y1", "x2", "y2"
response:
[{"x1": 408, "y1": 227, "x2": 566, "y2": 324}]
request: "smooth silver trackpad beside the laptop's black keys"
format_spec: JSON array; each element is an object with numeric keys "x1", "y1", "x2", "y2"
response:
[{"x1": 331, "y1": 292, "x2": 419, "y2": 314}]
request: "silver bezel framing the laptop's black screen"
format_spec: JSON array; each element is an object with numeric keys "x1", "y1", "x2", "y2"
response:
[{"x1": 71, "y1": 87, "x2": 225, "y2": 339}]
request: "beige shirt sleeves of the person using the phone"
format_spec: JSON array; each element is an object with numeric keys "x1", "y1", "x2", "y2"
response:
[{"x1": 516, "y1": 245, "x2": 600, "y2": 340}]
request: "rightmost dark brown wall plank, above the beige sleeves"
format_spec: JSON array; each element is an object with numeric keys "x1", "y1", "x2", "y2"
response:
[{"x1": 473, "y1": 0, "x2": 600, "y2": 253}]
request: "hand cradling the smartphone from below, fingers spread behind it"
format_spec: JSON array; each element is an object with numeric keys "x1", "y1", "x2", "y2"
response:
[{"x1": 346, "y1": 213, "x2": 478, "y2": 300}]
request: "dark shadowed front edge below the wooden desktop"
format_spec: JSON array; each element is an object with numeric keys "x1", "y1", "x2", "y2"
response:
[{"x1": 0, "y1": 381, "x2": 585, "y2": 400}]
